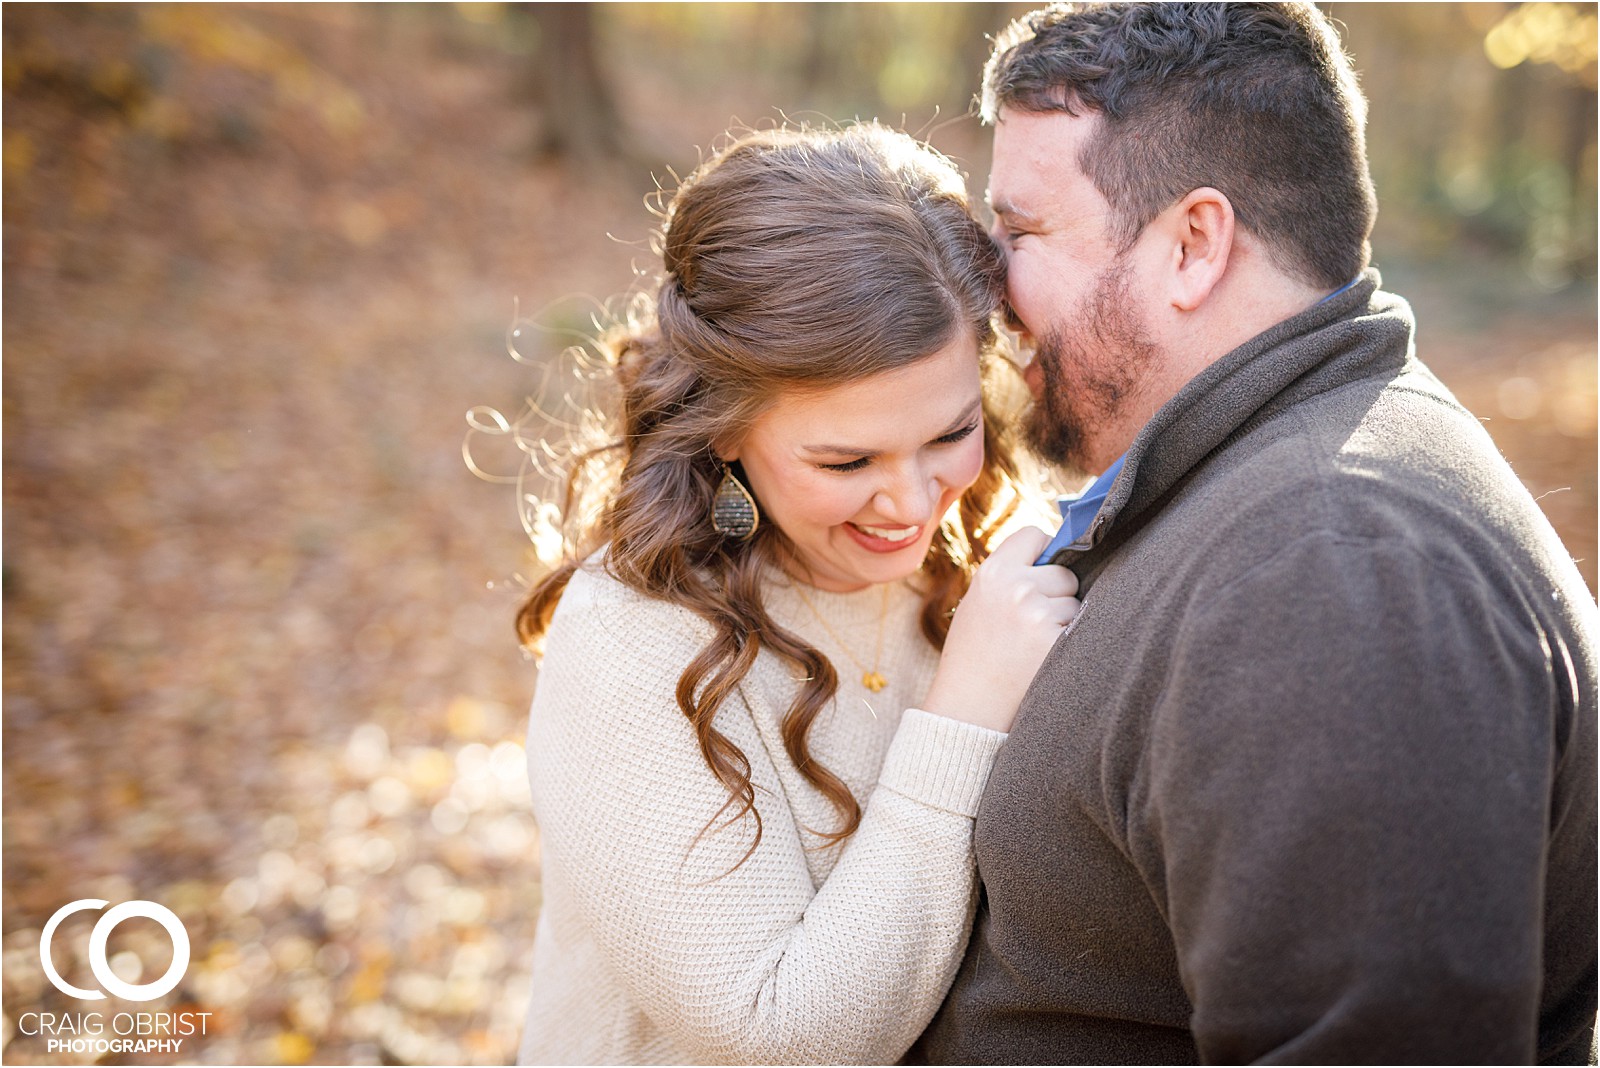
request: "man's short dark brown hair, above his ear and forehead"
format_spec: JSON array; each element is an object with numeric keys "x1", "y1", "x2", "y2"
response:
[{"x1": 982, "y1": 3, "x2": 1378, "y2": 288}]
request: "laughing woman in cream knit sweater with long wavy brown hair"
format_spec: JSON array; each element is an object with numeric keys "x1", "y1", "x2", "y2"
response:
[{"x1": 518, "y1": 125, "x2": 1077, "y2": 1063}]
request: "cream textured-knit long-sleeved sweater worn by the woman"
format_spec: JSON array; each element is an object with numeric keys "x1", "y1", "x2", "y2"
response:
[{"x1": 518, "y1": 566, "x2": 1005, "y2": 1063}]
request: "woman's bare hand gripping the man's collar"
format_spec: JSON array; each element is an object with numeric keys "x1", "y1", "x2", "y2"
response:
[{"x1": 923, "y1": 526, "x2": 1078, "y2": 731}]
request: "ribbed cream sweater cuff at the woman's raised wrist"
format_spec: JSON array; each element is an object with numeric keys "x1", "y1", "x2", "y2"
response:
[{"x1": 878, "y1": 708, "x2": 1006, "y2": 817}]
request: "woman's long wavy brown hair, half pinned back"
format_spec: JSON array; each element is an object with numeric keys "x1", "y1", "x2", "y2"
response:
[{"x1": 517, "y1": 123, "x2": 1018, "y2": 855}]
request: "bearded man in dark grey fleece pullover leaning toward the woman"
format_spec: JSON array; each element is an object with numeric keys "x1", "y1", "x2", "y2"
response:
[{"x1": 914, "y1": 3, "x2": 1597, "y2": 1063}]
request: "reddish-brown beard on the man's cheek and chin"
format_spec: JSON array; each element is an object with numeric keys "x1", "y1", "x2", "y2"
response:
[{"x1": 1022, "y1": 264, "x2": 1158, "y2": 475}]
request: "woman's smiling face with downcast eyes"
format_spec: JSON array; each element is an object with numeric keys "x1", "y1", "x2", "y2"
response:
[{"x1": 722, "y1": 331, "x2": 984, "y2": 592}]
